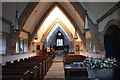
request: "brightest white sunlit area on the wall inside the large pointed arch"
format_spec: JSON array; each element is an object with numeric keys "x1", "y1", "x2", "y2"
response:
[{"x1": 42, "y1": 7, "x2": 74, "y2": 32}]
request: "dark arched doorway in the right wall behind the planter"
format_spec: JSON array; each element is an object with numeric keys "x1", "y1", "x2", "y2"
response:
[{"x1": 103, "y1": 19, "x2": 120, "y2": 61}]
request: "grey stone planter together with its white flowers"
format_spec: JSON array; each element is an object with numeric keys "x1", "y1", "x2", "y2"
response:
[{"x1": 83, "y1": 58, "x2": 118, "y2": 78}]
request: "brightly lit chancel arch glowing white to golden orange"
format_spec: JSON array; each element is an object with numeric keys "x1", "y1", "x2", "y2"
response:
[{"x1": 31, "y1": 6, "x2": 84, "y2": 52}]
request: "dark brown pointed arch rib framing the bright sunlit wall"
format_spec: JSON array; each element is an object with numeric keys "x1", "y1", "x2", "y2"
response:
[{"x1": 29, "y1": 2, "x2": 85, "y2": 47}]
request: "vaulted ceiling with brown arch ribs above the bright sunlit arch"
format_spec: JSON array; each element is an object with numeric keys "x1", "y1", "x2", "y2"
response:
[{"x1": 2, "y1": 2, "x2": 116, "y2": 47}]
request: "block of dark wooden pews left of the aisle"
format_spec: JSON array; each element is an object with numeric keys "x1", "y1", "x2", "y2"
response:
[{"x1": 2, "y1": 56, "x2": 54, "y2": 80}]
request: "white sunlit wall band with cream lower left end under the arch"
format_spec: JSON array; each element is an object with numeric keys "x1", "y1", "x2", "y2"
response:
[{"x1": 37, "y1": 7, "x2": 75, "y2": 42}]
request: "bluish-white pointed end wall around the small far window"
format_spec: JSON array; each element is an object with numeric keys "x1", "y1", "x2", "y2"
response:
[{"x1": 45, "y1": 23, "x2": 74, "y2": 51}]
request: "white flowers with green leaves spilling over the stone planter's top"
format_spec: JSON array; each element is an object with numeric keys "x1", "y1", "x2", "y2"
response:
[{"x1": 83, "y1": 58, "x2": 118, "y2": 69}]
